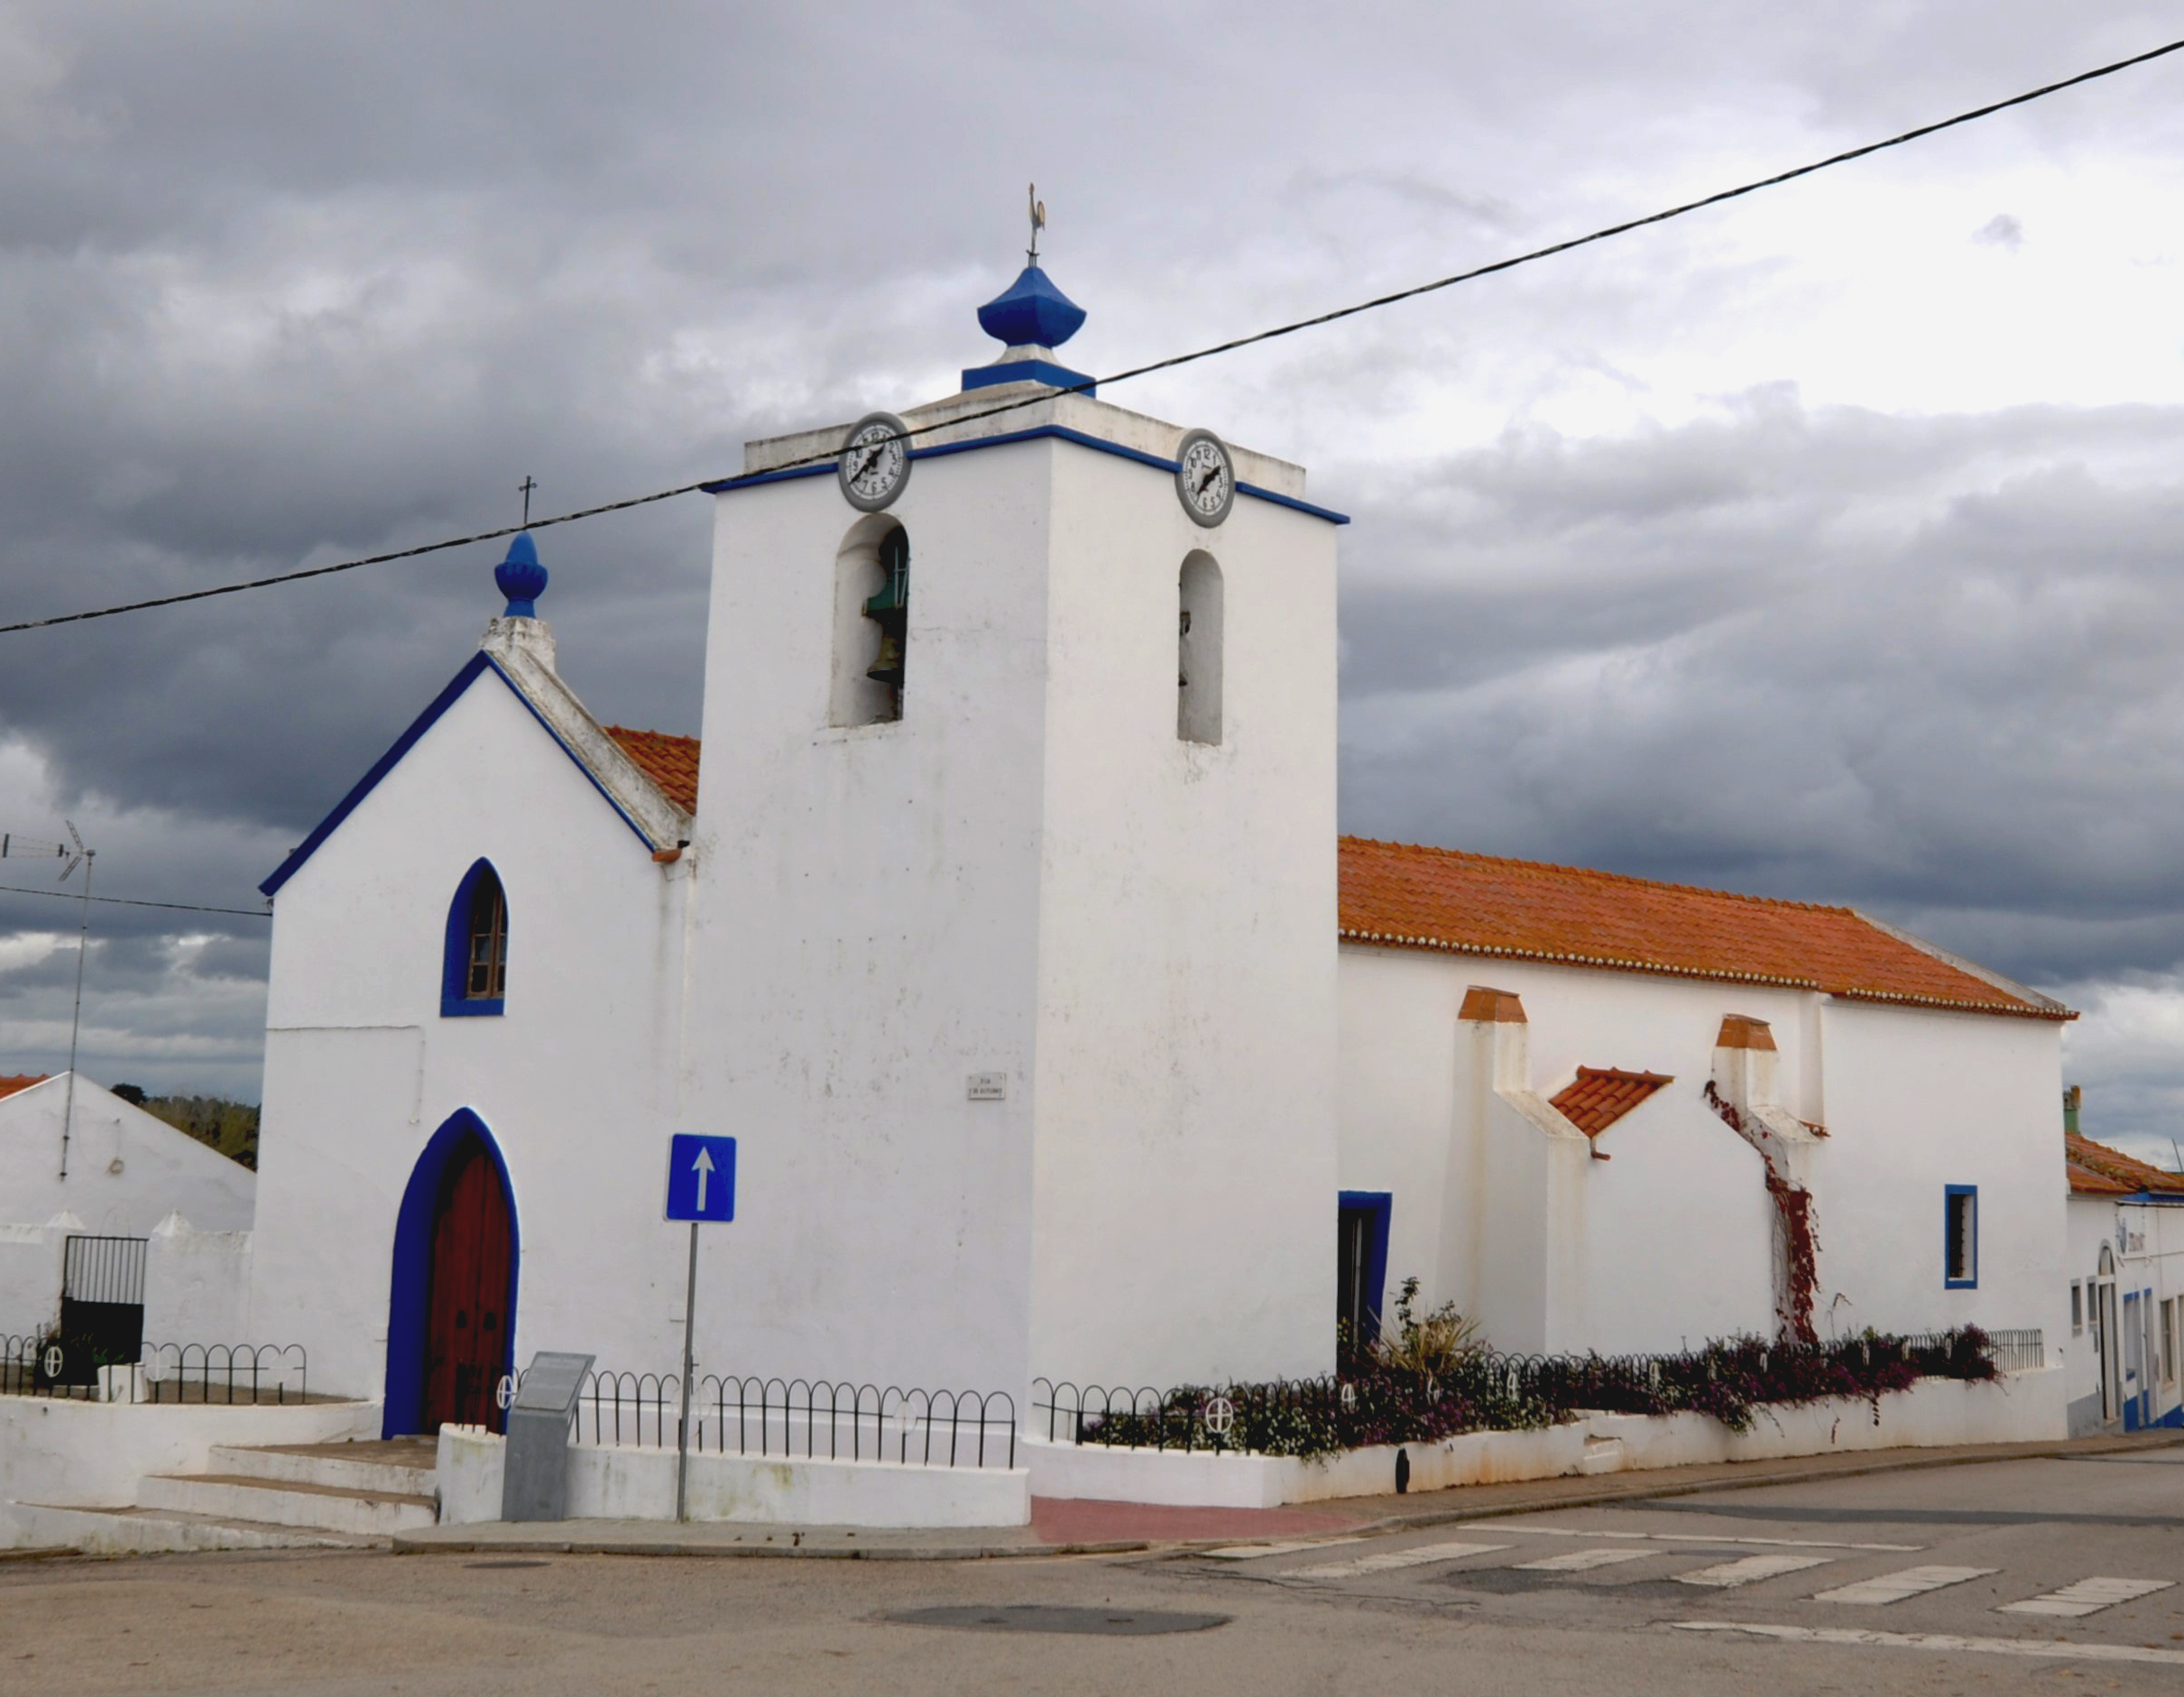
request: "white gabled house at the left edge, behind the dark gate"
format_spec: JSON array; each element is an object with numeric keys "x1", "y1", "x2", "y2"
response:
[{"x1": 0, "y1": 1073, "x2": 258, "y2": 1343}]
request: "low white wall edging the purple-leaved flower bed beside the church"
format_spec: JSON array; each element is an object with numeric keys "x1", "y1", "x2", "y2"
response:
[{"x1": 1022, "y1": 1367, "x2": 2069, "y2": 1509}]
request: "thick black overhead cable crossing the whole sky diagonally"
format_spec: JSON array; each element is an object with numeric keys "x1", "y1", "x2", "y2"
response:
[{"x1": 0, "y1": 40, "x2": 2184, "y2": 635}]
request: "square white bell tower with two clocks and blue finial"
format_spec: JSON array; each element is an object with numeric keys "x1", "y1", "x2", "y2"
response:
[{"x1": 675, "y1": 255, "x2": 1343, "y2": 1408}]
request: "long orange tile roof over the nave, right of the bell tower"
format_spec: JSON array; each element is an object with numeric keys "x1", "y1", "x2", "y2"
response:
[{"x1": 1341, "y1": 836, "x2": 2077, "y2": 1020}]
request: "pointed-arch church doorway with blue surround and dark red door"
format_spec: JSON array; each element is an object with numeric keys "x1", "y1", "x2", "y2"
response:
[{"x1": 380, "y1": 1107, "x2": 520, "y2": 1437}]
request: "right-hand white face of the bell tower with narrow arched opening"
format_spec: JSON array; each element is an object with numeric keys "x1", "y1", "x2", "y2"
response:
[{"x1": 1026, "y1": 429, "x2": 1339, "y2": 1385}]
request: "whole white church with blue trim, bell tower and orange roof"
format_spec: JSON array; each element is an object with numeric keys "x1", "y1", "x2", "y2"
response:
[{"x1": 249, "y1": 266, "x2": 2073, "y2": 1433}]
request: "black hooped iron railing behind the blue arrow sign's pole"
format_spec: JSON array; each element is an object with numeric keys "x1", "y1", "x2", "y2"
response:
[{"x1": 550, "y1": 1371, "x2": 1016, "y2": 1468}]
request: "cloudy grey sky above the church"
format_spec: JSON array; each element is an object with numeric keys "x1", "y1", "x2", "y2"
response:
[{"x1": 0, "y1": 0, "x2": 2184, "y2": 1162}]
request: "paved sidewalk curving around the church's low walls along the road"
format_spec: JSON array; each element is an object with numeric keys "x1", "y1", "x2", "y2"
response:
[{"x1": 393, "y1": 1428, "x2": 2184, "y2": 1562}]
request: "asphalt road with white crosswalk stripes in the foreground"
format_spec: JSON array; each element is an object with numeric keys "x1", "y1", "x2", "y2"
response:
[{"x1": 0, "y1": 1448, "x2": 2184, "y2": 1697}]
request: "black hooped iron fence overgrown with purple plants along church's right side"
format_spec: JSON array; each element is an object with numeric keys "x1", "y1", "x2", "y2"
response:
[{"x1": 1031, "y1": 1325, "x2": 2046, "y2": 1454}]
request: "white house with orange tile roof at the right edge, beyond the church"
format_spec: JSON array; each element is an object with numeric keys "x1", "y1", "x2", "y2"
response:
[{"x1": 2064, "y1": 1101, "x2": 2184, "y2": 1434}]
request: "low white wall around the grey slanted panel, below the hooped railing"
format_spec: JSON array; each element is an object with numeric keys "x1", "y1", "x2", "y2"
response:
[{"x1": 439, "y1": 1426, "x2": 1031, "y2": 1526}]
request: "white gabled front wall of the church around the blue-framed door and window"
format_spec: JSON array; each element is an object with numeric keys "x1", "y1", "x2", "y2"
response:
[{"x1": 249, "y1": 673, "x2": 688, "y2": 1397}]
